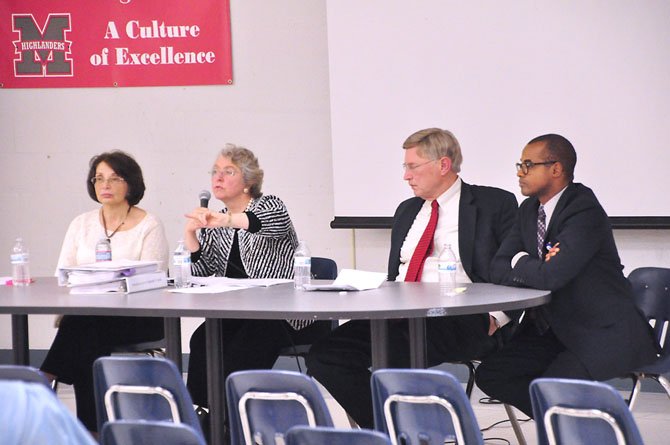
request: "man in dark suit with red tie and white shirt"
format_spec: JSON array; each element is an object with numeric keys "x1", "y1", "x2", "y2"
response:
[{"x1": 307, "y1": 128, "x2": 519, "y2": 428}]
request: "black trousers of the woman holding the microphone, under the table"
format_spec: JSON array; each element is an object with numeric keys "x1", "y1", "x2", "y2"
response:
[{"x1": 186, "y1": 319, "x2": 330, "y2": 407}]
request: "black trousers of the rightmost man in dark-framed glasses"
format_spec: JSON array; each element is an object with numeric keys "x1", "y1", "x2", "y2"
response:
[{"x1": 476, "y1": 322, "x2": 593, "y2": 418}]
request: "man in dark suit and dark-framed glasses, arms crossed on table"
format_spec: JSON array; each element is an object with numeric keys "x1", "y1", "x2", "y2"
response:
[{"x1": 477, "y1": 134, "x2": 656, "y2": 417}]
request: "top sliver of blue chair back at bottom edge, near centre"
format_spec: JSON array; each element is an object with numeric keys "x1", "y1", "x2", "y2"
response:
[{"x1": 284, "y1": 426, "x2": 391, "y2": 445}]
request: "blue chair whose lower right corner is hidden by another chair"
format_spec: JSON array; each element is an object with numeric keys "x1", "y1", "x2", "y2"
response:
[{"x1": 226, "y1": 370, "x2": 333, "y2": 445}]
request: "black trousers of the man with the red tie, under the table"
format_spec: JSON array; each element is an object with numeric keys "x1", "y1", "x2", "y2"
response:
[{"x1": 306, "y1": 314, "x2": 504, "y2": 428}]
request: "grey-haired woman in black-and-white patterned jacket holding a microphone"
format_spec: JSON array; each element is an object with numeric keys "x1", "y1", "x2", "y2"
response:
[{"x1": 184, "y1": 144, "x2": 320, "y2": 407}]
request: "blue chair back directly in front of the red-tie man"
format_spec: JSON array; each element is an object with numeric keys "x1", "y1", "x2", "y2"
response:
[{"x1": 372, "y1": 369, "x2": 484, "y2": 445}]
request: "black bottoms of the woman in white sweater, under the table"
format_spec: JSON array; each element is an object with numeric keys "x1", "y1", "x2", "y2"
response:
[{"x1": 40, "y1": 315, "x2": 164, "y2": 431}]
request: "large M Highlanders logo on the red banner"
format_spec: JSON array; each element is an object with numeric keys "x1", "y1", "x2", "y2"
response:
[{"x1": 12, "y1": 14, "x2": 72, "y2": 77}]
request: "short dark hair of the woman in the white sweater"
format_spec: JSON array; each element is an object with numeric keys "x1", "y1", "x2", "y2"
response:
[{"x1": 86, "y1": 150, "x2": 146, "y2": 206}]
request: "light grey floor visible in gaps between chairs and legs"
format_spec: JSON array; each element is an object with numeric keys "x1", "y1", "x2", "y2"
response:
[{"x1": 58, "y1": 378, "x2": 670, "y2": 445}]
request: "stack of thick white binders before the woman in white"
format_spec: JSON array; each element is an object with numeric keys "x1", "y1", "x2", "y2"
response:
[{"x1": 58, "y1": 260, "x2": 167, "y2": 294}]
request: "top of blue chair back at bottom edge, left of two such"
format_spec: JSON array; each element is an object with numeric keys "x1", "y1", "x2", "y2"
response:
[{"x1": 100, "y1": 420, "x2": 206, "y2": 445}]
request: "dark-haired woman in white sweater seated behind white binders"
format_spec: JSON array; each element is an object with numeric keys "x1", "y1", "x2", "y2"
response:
[{"x1": 41, "y1": 151, "x2": 169, "y2": 431}]
